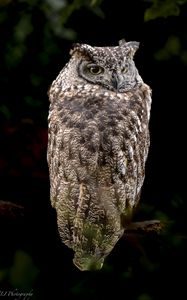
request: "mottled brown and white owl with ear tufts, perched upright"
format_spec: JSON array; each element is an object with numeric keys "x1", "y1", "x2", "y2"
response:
[{"x1": 48, "y1": 40, "x2": 151, "y2": 270}]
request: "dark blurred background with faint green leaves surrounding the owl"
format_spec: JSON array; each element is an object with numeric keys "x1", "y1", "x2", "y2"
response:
[{"x1": 0, "y1": 0, "x2": 187, "y2": 300}]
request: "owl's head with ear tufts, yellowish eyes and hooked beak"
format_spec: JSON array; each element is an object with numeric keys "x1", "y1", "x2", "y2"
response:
[{"x1": 66, "y1": 40, "x2": 142, "y2": 93}]
